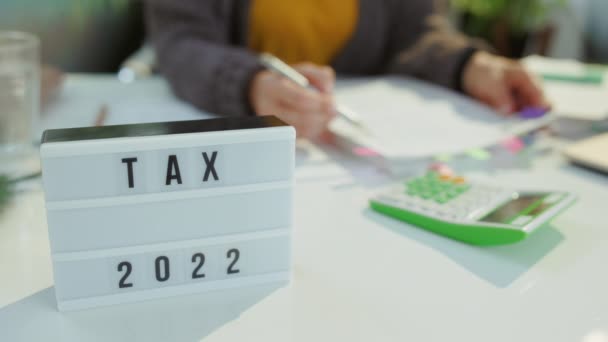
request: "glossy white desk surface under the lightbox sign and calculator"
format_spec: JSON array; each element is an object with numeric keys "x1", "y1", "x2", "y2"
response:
[{"x1": 0, "y1": 75, "x2": 608, "y2": 342}]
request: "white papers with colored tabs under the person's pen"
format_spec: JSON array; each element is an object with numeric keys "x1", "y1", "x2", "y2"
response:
[{"x1": 331, "y1": 78, "x2": 550, "y2": 174}]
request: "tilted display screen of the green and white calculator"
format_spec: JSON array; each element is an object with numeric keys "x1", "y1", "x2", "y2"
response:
[{"x1": 480, "y1": 194, "x2": 552, "y2": 223}]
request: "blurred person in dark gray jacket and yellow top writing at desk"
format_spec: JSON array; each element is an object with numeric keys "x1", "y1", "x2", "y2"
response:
[{"x1": 146, "y1": 0, "x2": 547, "y2": 139}]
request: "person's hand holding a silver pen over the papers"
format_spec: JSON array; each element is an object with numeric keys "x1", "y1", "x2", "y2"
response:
[{"x1": 249, "y1": 63, "x2": 336, "y2": 140}]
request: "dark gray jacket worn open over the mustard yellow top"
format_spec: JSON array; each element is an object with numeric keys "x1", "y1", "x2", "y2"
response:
[{"x1": 147, "y1": 0, "x2": 482, "y2": 115}]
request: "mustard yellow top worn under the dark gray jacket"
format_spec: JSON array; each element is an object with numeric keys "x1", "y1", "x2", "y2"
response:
[{"x1": 249, "y1": 0, "x2": 359, "y2": 65}]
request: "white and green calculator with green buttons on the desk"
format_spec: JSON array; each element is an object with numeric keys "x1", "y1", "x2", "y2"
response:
[{"x1": 370, "y1": 171, "x2": 576, "y2": 246}]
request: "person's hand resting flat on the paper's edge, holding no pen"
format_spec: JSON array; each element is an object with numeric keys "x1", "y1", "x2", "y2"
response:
[{"x1": 462, "y1": 51, "x2": 550, "y2": 114}]
